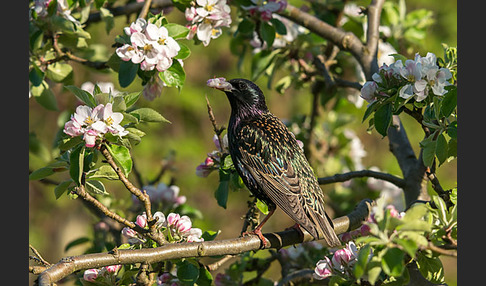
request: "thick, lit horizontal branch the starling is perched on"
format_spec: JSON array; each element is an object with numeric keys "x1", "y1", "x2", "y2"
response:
[{"x1": 38, "y1": 200, "x2": 371, "y2": 286}]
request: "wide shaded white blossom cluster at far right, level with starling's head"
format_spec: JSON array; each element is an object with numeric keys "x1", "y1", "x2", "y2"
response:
[{"x1": 361, "y1": 53, "x2": 452, "y2": 103}]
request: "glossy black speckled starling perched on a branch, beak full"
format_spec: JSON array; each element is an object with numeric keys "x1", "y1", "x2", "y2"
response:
[{"x1": 208, "y1": 78, "x2": 341, "y2": 247}]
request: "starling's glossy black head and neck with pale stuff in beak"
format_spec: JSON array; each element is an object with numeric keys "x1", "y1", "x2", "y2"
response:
[{"x1": 207, "y1": 78, "x2": 268, "y2": 117}]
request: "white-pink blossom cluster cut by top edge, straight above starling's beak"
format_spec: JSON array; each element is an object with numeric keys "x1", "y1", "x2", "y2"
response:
[{"x1": 185, "y1": 0, "x2": 231, "y2": 46}]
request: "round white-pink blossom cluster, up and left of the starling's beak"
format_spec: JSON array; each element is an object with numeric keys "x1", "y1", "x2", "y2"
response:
[{"x1": 116, "y1": 18, "x2": 181, "y2": 71}]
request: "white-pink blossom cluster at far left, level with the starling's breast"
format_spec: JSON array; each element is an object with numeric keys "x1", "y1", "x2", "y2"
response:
[{"x1": 64, "y1": 103, "x2": 128, "y2": 147}]
